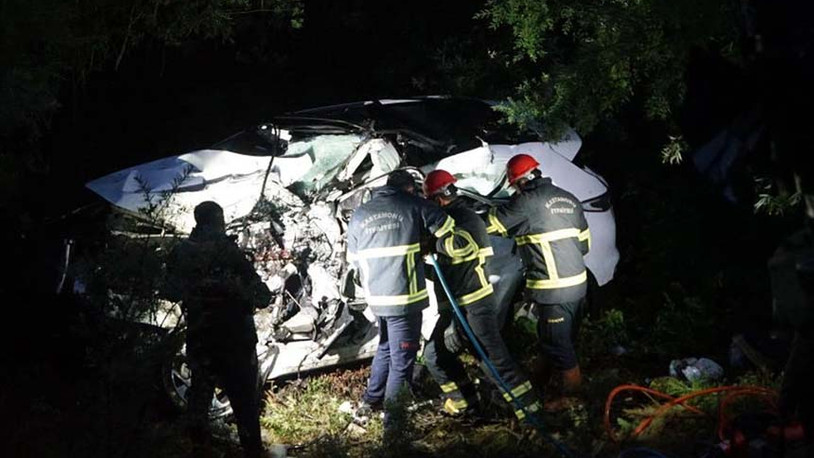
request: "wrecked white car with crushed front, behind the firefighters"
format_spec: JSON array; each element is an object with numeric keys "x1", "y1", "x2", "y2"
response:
[{"x1": 79, "y1": 98, "x2": 619, "y2": 415}]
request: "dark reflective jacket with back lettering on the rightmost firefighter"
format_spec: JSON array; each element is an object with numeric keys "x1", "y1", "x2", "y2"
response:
[{"x1": 487, "y1": 178, "x2": 591, "y2": 304}]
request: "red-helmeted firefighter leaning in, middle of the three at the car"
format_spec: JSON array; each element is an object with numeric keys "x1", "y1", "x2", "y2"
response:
[{"x1": 424, "y1": 170, "x2": 542, "y2": 420}]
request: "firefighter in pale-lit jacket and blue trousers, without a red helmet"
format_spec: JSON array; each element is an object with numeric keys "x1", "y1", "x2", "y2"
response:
[{"x1": 348, "y1": 170, "x2": 455, "y2": 426}]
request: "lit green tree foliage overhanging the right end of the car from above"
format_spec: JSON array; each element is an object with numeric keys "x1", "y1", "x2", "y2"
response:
[{"x1": 479, "y1": 0, "x2": 736, "y2": 138}]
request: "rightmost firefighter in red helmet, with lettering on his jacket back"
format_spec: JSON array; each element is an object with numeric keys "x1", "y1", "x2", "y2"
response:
[{"x1": 487, "y1": 154, "x2": 591, "y2": 408}]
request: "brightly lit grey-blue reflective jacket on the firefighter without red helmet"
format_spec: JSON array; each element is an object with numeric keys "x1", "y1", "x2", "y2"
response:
[{"x1": 348, "y1": 186, "x2": 460, "y2": 316}]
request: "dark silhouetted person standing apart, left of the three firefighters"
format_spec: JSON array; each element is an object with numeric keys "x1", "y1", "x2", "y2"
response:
[{"x1": 165, "y1": 201, "x2": 271, "y2": 457}]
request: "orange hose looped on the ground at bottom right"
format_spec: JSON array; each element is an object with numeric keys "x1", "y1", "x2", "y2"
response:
[{"x1": 604, "y1": 385, "x2": 776, "y2": 443}]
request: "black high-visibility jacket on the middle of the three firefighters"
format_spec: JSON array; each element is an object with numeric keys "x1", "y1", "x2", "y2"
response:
[{"x1": 438, "y1": 199, "x2": 494, "y2": 306}]
